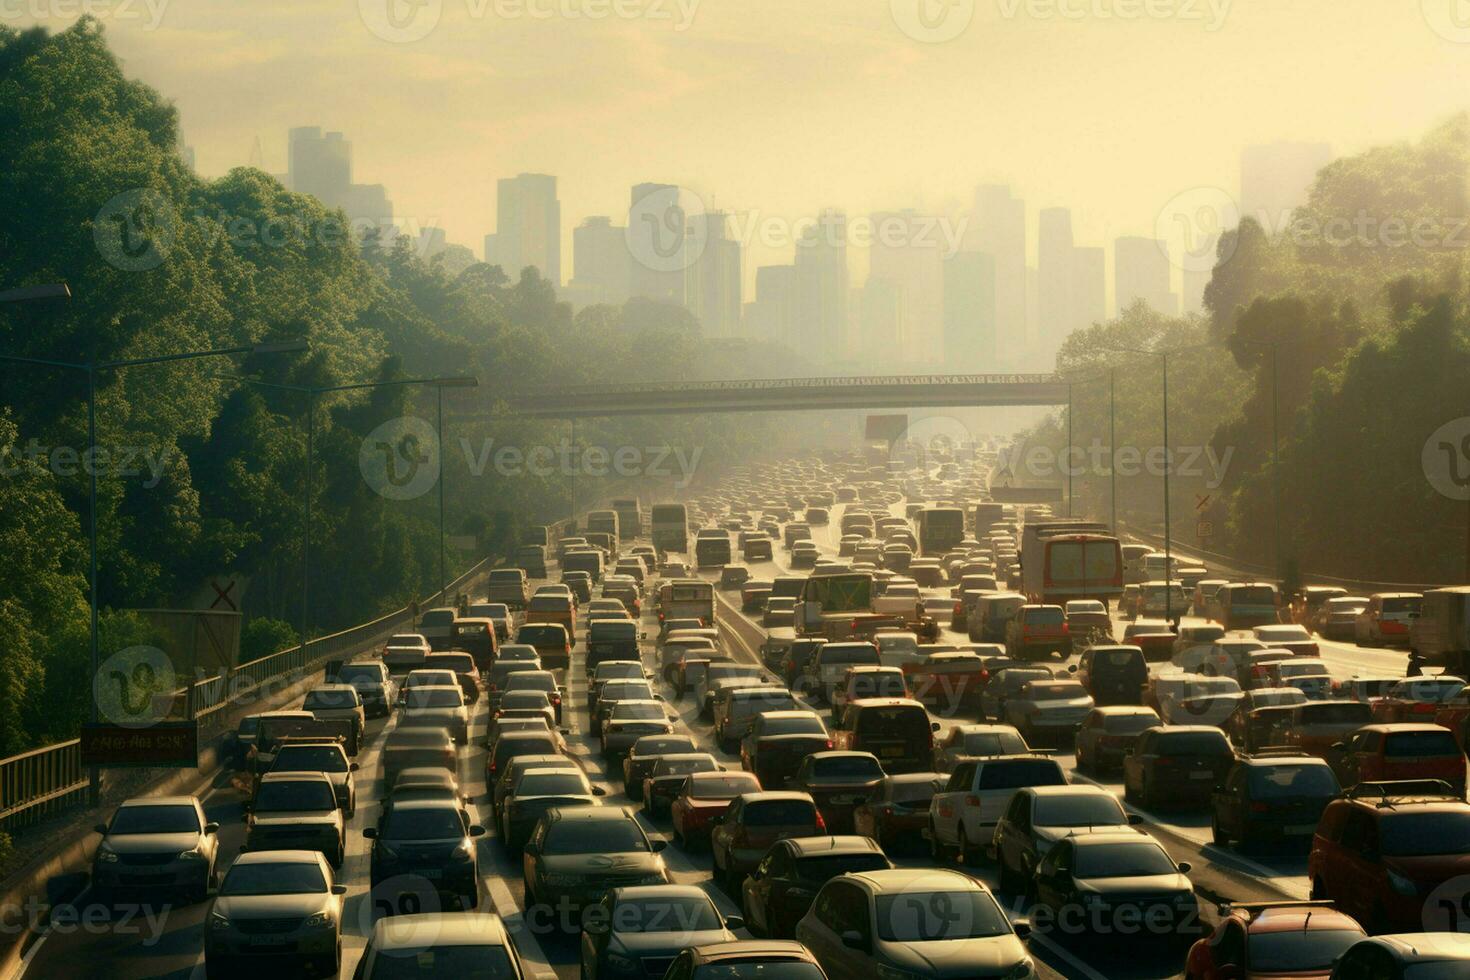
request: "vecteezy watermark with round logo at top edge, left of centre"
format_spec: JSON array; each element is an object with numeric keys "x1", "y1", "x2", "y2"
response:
[{"x1": 357, "y1": 0, "x2": 703, "y2": 44}]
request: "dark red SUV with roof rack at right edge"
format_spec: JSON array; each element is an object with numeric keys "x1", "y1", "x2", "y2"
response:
[{"x1": 1307, "y1": 780, "x2": 1470, "y2": 933}]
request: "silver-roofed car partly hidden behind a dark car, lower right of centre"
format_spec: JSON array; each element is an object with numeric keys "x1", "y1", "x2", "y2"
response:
[{"x1": 986, "y1": 785, "x2": 1144, "y2": 892}]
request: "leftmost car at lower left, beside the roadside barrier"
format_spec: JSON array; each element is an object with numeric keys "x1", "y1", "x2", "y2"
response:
[{"x1": 91, "y1": 796, "x2": 219, "y2": 902}]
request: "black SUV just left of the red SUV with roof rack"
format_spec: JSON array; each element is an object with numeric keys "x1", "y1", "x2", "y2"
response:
[{"x1": 1210, "y1": 751, "x2": 1342, "y2": 849}]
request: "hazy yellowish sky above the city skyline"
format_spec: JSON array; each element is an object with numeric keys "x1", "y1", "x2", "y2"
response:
[{"x1": 11, "y1": 0, "x2": 1470, "y2": 290}]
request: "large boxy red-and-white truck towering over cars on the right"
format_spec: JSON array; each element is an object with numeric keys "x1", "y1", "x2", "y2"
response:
[{"x1": 1020, "y1": 520, "x2": 1123, "y2": 605}]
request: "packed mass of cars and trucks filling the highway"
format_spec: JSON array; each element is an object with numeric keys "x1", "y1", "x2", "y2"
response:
[{"x1": 42, "y1": 447, "x2": 1470, "y2": 980}]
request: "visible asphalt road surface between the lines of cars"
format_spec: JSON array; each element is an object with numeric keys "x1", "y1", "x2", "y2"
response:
[{"x1": 8, "y1": 507, "x2": 1405, "y2": 980}]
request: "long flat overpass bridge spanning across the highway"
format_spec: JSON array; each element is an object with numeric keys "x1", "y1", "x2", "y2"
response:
[{"x1": 504, "y1": 375, "x2": 1067, "y2": 419}]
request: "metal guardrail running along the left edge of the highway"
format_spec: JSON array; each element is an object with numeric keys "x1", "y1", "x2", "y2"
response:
[{"x1": 0, "y1": 558, "x2": 494, "y2": 830}]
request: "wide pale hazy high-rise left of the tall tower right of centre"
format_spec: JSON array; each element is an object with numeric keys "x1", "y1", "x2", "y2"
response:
[{"x1": 869, "y1": 209, "x2": 944, "y2": 363}]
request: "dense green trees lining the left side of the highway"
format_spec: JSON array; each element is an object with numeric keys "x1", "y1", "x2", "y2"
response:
[{"x1": 0, "y1": 18, "x2": 770, "y2": 755}]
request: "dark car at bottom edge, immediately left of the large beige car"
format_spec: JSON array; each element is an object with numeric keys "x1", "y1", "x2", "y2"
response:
[{"x1": 581, "y1": 884, "x2": 745, "y2": 980}]
